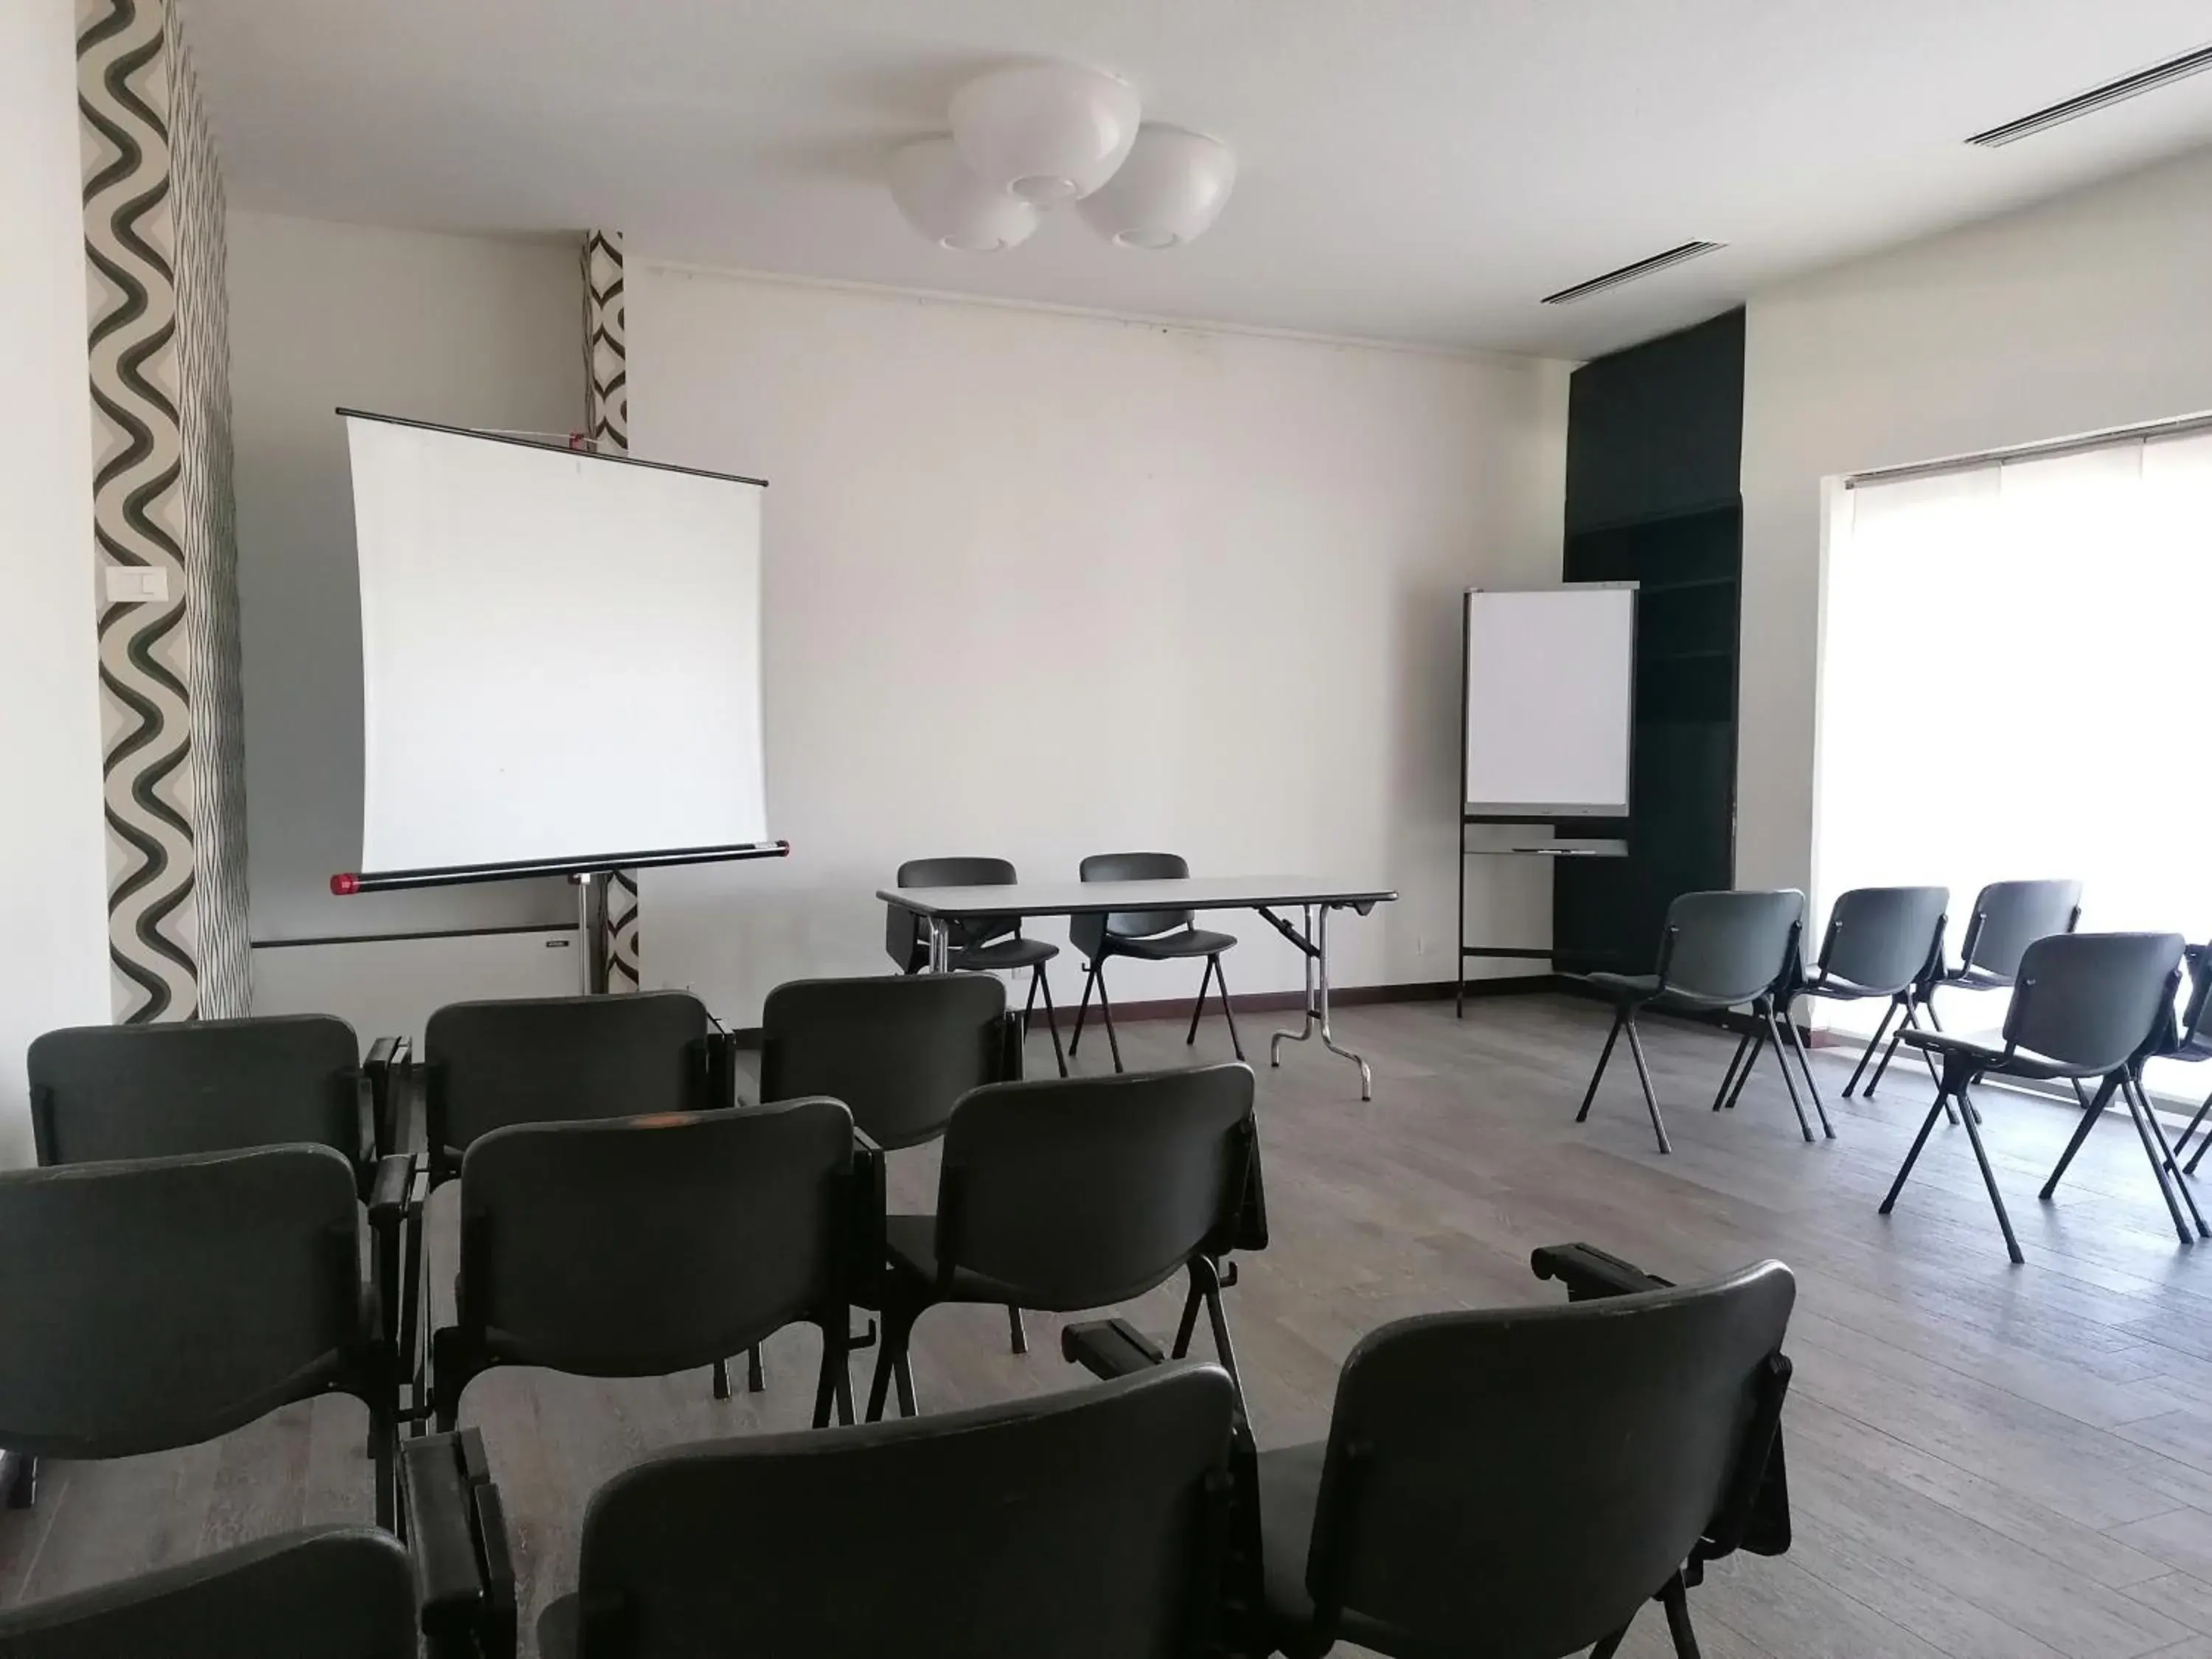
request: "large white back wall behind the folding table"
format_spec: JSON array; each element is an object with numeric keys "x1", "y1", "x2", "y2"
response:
[{"x1": 628, "y1": 268, "x2": 1566, "y2": 1024}]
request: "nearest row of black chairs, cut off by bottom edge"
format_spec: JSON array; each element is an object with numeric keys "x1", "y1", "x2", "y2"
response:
[{"x1": 0, "y1": 1245, "x2": 1794, "y2": 1659}]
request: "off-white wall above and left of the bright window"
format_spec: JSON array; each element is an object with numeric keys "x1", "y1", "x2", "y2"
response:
[{"x1": 1736, "y1": 150, "x2": 2212, "y2": 902}]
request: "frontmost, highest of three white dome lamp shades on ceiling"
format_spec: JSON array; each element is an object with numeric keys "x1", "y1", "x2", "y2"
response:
[{"x1": 951, "y1": 64, "x2": 1139, "y2": 208}]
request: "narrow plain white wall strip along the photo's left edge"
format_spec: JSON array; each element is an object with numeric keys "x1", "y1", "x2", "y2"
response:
[{"x1": 0, "y1": 4, "x2": 108, "y2": 1166}]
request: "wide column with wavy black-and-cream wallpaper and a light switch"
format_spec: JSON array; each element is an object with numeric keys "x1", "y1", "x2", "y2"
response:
[{"x1": 77, "y1": 0, "x2": 250, "y2": 1022}]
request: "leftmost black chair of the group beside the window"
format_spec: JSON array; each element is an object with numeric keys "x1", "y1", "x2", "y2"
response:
[{"x1": 1575, "y1": 887, "x2": 1836, "y2": 1152}]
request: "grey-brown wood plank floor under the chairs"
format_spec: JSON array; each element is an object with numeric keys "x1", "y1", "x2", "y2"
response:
[{"x1": 0, "y1": 998, "x2": 2212, "y2": 1659}]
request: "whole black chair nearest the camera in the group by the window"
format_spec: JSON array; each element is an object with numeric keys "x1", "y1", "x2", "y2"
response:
[{"x1": 1880, "y1": 933, "x2": 2203, "y2": 1261}]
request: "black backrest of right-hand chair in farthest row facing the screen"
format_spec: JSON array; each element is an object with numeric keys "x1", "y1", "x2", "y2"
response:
[{"x1": 761, "y1": 973, "x2": 1022, "y2": 1150}]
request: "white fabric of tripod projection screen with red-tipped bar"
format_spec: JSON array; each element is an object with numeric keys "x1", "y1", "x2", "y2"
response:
[{"x1": 345, "y1": 416, "x2": 768, "y2": 872}]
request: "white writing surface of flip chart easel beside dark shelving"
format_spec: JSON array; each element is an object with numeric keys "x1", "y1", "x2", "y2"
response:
[{"x1": 1464, "y1": 584, "x2": 1637, "y2": 818}]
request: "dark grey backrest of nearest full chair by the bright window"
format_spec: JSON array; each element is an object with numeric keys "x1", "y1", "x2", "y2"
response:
[{"x1": 2004, "y1": 933, "x2": 2185, "y2": 1075}]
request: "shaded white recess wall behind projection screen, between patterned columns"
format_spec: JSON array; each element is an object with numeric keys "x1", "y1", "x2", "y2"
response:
[{"x1": 230, "y1": 212, "x2": 584, "y2": 947}]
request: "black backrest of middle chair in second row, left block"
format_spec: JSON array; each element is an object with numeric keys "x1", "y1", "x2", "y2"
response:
[{"x1": 458, "y1": 1099, "x2": 854, "y2": 1376}]
